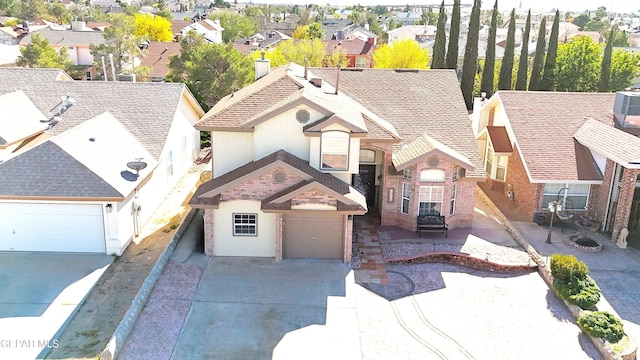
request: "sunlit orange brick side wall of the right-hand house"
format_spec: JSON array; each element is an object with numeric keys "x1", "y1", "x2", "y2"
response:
[{"x1": 503, "y1": 147, "x2": 544, "y2": 219}]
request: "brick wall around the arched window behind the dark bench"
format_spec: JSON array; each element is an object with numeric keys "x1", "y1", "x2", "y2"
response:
[{"x1": 380, "y1": 156, "x2": 476, "y2": 230}]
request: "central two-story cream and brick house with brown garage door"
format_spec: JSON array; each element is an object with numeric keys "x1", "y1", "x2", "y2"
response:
[{"x1": 190, "y1": 60, "x2": 485, "y2": 262}]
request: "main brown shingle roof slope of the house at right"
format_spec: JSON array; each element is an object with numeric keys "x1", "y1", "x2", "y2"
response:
[{"x1": 496, "y1": 91, "x2": 615, "y2": 182}]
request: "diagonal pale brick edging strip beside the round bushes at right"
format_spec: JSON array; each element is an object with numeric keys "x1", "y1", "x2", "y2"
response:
[{"x1": 476, "y1": 186, "x2": 635, "y2": 360}]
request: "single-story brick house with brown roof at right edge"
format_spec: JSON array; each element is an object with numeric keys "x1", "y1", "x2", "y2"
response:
[{"x1": 473, "y1": 91, "x2": 640, "y2": 248}]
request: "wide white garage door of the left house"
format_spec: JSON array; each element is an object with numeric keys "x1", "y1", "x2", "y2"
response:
[{"x1": 0, "y1": 203, "x2": 105, "y2": 252}]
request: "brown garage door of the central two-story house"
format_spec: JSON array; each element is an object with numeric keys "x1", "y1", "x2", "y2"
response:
[{"x1": 284, "y1": 211, "x2": 344, "y2": 259}]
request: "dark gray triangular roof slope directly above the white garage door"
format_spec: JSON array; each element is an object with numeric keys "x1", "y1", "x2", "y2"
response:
[{"x1": 0, "y1": 141, "x2": 123, "y2": 200}]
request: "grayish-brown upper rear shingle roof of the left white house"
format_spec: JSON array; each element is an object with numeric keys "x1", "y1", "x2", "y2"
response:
[{"x1": 0, "y1": 68, "x2": 186, "y2": 159}]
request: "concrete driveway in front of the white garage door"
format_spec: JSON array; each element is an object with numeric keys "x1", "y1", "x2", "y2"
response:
[{"x1": 0, "y1": 253, "x2": 113, "y2": 359}]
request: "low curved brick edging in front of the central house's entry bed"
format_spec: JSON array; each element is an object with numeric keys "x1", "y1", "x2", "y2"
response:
[{"x1": 387, "y1": 252, "x2": 538, "y2": 273}]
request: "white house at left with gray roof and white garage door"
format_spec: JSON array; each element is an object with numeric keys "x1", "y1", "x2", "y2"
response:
[{"x1": 0, "y1": 68, "x2": 203, "y2": 255}]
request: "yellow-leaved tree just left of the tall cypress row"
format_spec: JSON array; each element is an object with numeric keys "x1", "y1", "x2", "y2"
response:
[{"x1": 373, "y1": 39, "x2": 429, "y2": 69}]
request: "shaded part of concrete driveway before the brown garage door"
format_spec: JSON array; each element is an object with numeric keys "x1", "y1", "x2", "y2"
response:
[{"x1": 172, "y1": 258, "x2": 356, "y2": 359}]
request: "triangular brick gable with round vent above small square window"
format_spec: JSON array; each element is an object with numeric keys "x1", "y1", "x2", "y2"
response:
[{"x1": 220, "y1": 167, "x2": 303, "y2": 202}]
